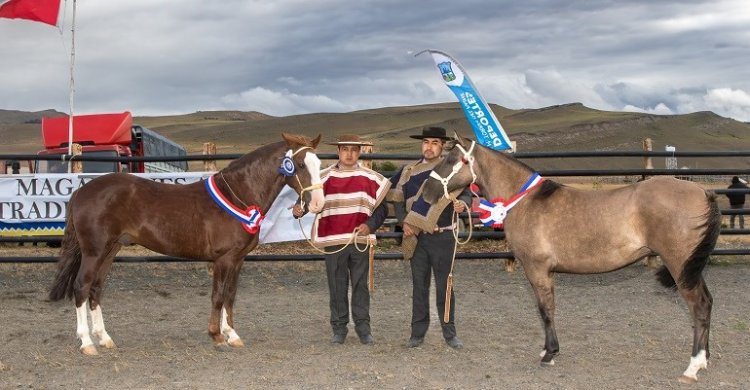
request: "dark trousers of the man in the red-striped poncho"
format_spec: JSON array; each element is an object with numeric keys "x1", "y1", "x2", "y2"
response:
[{"x1": 325, "y1": 245, "x2": 370, "y2": 335}]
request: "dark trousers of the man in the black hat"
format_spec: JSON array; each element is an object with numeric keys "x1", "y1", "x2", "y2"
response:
[{"x1": 411, "y1": 232, "x2": 456, "y2": 340}]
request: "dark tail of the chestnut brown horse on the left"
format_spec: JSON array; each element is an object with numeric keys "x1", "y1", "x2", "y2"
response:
[{"x1": 49, "y1": 210, "x2": 81, "y2": 301}]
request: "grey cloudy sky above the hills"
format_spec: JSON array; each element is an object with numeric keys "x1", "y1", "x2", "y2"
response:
[{"x1": 0, "y1": 0, "x2": 750, "y2": 121}]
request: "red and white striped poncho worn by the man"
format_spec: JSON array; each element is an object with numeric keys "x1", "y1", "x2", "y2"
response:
[{"x1": 312, "y1": 165, "x2": 391, "y2": 248}]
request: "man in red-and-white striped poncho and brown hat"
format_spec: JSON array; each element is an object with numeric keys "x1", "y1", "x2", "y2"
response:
[{"x1": 292, "y1": 134, "x2": 391, "y2": 344}]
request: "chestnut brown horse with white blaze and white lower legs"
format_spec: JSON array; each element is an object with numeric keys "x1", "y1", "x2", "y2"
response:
[{"x1": 49, "y1": 134, "x2": 323, "y2": 355}]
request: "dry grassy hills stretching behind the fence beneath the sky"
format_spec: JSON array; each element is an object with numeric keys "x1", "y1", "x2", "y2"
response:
[{"x1": 0, "y1": 103, "x2": 750, "y2": 169}]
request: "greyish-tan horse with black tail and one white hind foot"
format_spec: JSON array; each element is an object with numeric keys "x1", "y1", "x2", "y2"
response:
[{"x1": 422, "y1": 135, "x2": 720, "y2": 383}]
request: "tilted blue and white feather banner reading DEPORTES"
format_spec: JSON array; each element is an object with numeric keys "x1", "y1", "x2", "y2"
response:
[{"x1": 415, "y1": 49, "x2": 512, "y2": 150}]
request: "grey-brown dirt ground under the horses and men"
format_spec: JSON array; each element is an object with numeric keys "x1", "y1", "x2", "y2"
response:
[{"x1": 0, "y1": 242, "x2": 750, "y2": 389}]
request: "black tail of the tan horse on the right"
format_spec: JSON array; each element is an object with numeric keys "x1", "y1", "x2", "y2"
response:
[{"x1": 656, "y1": 191, "x2": 721, "y2": 289}]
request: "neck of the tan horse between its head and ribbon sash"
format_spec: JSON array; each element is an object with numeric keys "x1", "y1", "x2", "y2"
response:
[{"x1": 474, "y1": 149, "x2": 534, "y2": 199}]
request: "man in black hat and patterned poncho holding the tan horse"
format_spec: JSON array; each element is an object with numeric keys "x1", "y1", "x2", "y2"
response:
[{"x1": 388, "y1": 127, "x2": 471, "y2": 349}]
